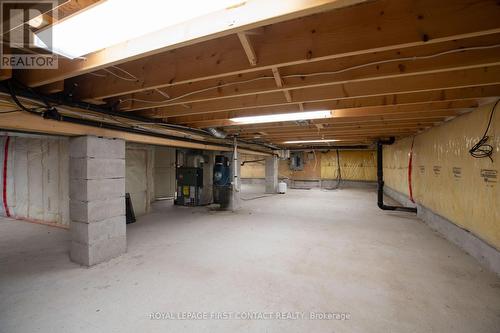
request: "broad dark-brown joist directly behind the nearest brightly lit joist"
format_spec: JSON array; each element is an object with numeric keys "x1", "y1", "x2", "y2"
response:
[{"x1": 49, "y1": 0, "x2": 500, "y2": 99}]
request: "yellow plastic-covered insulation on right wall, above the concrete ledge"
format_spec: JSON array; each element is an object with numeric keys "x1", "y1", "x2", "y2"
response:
[{"x1": 384, "y1": 105, "x2": 500, "y2": 250}]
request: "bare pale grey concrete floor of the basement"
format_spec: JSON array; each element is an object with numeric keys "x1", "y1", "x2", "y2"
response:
[{"x1": 0, "y1": 186, "x2": 500, "y2": 333}]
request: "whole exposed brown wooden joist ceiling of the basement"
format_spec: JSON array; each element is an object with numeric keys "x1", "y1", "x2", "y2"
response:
[{"x1": 2, "y1": 0, "x2": 500, "y2": 145}]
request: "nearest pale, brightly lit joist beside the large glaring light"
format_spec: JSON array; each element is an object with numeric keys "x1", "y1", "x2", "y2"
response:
[{"x1": 18, "y1": 0, "x2": 368, "y2": 87}]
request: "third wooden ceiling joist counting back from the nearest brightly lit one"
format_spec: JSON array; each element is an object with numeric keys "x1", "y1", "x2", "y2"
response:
[{"x1": 117, "y1": 35, "x2": 500, "y2": 110}]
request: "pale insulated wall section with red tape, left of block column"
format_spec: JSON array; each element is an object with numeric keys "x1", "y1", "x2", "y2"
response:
[{"x1": 0, "y1": 136, "x2": 69, "y2": 226}]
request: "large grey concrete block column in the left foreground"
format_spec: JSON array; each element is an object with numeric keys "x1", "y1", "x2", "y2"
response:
[{"x1": 70, "y1": 136, "x2": 127, "y2": 266}]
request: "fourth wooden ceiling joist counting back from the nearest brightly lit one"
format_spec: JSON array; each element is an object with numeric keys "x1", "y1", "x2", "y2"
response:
[{"x1": 143, "y1": 65, "x2": 500, "y2": 118}]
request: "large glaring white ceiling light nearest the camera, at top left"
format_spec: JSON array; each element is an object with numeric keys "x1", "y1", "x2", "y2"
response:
[{"x1": 34, "y1": 0, "x2": 241, "y2": 59}]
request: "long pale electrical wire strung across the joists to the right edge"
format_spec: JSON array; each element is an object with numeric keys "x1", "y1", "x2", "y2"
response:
[{"x1": 96, "y1": 44, "x2": 500, "y2": 104}]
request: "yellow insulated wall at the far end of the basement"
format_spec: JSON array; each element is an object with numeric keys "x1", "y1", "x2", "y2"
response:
[{"x1": 241, "y1": 150, "x2": 377, "y2": 181}]
